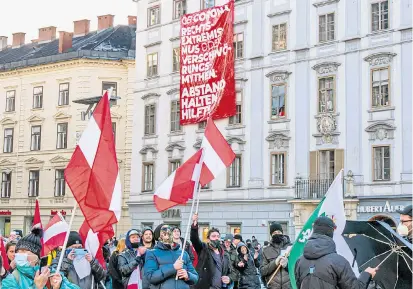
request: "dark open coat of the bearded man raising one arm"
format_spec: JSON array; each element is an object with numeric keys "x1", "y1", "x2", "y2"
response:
[{"x1": 191, "y1": 225, "x2": 233, "y2": 289}]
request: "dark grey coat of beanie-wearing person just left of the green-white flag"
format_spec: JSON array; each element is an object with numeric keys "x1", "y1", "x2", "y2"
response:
[{"x1": 260, "y1": 236, "x2": 291, "y2": 289}]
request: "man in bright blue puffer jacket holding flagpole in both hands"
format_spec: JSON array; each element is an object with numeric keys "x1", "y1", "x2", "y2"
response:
[{"x1": 144, "y1": 225, "x2": 198, "y2": 289}]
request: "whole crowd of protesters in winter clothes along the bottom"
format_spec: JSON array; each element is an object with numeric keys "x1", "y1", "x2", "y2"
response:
[{"x1": 0, "y1": 202, "x2": 412, "y2": 289}]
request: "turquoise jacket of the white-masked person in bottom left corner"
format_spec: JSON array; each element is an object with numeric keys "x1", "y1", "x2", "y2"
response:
[{"x1": 0, "y1": 268, "x2": 81, "y2": 289}]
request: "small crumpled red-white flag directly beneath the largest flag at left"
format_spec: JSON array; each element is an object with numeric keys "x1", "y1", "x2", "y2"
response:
[{"x1": 79, "y1": 220, "x2": 115, "y2": 268}]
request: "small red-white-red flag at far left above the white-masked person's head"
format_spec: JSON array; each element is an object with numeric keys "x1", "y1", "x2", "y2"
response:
[{"x1": 42, "y1": 213, "x2": 69, "y2": 256}]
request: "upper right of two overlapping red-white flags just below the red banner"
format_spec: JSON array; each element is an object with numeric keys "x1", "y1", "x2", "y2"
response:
[{"x1": 199, "y1": 118, "x2": 235, "y2": 186}]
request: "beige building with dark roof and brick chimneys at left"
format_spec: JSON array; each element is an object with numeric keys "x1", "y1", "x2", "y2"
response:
[{"x1": 0, "y1": 15, "x2": 136, "y2": 235}]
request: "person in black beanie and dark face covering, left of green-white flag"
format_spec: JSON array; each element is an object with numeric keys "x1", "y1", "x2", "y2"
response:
[{"x1": 260, "y1": 222, "x2": 292, "y2": 289}]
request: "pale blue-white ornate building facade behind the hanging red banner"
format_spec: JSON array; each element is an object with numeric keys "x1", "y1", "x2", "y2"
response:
[{"x1": 128, "y1": 0, "x2": 412, "y2": 240}]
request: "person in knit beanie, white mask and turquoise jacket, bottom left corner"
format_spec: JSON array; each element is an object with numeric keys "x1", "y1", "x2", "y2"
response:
[{"x1": 2, "y1": 227, "x2": 80, "y2": 289}]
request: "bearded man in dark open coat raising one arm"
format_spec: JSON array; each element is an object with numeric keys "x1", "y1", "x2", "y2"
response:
[{"x1": 191, "y1": 214, "x2": 231, "y2": 289}]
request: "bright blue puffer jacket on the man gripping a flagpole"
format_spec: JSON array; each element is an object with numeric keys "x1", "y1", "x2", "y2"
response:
[{"x1": 144, "y1": 242, "x2": 198, "y2": 289}]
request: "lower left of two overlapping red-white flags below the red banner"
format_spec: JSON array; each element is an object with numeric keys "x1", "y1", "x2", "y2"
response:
[{"x1": 153, "y1": 149, "x2": 203, "y2": 212}]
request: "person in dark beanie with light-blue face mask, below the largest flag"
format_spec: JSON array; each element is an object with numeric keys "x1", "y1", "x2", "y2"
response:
[{"x1": 52, "y1": 231, "x2": 107, "y2": 289}]
